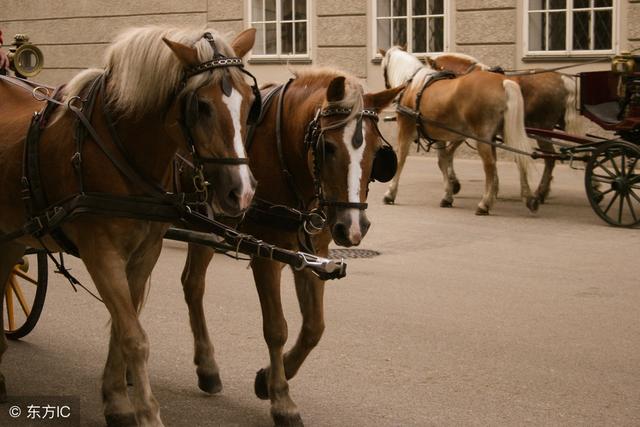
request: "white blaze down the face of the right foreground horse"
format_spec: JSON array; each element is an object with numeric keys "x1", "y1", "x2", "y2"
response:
[{"x1": 342, "y1": 120, "x2": 367, "y2": 243}]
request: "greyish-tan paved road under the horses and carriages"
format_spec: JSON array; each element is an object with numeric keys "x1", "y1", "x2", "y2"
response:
[{"x1": 2, "y1": 157, "x2": 640, "y2": 426}]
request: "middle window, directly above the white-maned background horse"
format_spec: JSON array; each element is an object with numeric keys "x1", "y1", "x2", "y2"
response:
[{"x1": 374, "y1": 0, "x2": 447, "y2": 53}]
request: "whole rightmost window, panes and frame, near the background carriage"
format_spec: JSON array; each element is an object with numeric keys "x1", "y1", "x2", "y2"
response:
[{"x1": 526, "y1": 0, "x2": 615, "y2": 55}]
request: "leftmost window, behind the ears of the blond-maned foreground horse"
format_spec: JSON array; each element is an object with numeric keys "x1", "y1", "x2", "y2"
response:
[{"x1": 249, "y1": 0, "x2": 309, "y2": 57}]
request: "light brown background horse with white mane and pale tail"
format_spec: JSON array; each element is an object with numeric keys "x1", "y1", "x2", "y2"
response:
[{"x1": 381, "y1": 46, "x2": 538, "y2": 215}]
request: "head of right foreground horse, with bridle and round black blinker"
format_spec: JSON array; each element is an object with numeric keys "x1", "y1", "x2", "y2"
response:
[{"x1": 308, "y1": 76, "x2": 402, "y2": 246}]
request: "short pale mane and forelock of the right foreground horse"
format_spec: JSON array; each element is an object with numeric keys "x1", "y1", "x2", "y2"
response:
[{"x1": 293, "y1": 67, "x2": 364, "y2": 121}]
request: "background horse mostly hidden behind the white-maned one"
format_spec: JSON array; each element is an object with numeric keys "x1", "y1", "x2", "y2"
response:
[{"x1": 427, "y1": 53, "x2": 582, "y2": 203}]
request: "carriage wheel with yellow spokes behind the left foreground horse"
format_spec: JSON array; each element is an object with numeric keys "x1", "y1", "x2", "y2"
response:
[{"x1": 2, "y1": 251, "x2": 48, "y2": 340}]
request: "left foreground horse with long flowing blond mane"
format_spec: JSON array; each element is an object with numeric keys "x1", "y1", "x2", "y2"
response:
[{"x1": 0, "y1": 27, "x2": 255, "y2": 426}]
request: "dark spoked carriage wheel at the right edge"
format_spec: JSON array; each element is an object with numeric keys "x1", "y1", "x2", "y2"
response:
[{"x1": 585, "y1": 141, "x2": 640, "y2": 227}]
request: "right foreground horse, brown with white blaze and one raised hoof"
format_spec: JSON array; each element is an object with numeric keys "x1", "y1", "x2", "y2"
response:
[{"x1": 182, "y1": 69, "x2": 400, "y2": 425}]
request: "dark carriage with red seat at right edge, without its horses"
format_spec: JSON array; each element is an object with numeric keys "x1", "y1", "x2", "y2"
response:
[{"x1": 527, "y1": 53, "x2": 640, "y2": 227}]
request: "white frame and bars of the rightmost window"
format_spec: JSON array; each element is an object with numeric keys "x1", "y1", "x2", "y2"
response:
[{"x1": 522, "y1": 0, "x2": 620, "y2": 58}]
